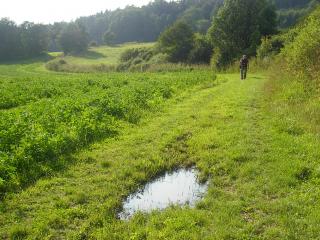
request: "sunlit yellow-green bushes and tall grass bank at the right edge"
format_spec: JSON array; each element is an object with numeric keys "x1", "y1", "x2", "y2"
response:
[{"x1": 266, "y1": 7, "x2": 320, "y2": 134}]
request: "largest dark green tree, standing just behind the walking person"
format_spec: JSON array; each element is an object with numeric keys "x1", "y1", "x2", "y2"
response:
[{"x1": 209, "y1": 0, "x2": 277, "y2": 66}]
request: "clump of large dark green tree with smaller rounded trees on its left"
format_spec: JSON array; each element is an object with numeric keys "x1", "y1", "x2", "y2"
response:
[{"x1": 158, "y1": 0, "x2": 277, "y2": 67}]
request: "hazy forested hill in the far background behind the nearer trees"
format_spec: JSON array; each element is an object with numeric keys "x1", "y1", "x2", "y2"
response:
[{"x1": 76, "y1": 0, "x2": 318, "y2": 44}]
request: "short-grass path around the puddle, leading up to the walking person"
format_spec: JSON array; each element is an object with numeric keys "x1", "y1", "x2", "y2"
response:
[{"x1": 0, "y1": 70, "x2": 320, "y2": 239}]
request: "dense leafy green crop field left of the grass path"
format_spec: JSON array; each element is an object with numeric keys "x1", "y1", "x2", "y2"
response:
[{"x1": 0, "y1": 58, "x2": 212, "y2": 195}]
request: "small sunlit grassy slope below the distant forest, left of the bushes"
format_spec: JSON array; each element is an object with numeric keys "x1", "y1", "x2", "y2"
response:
[{"x1": 52, "y1": 43, "x2": 154, "y2": 65}]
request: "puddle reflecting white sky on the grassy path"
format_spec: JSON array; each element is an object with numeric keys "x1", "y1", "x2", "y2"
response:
[{"x1": 119, "y1": 169, "x2": 208, "y2": 220}]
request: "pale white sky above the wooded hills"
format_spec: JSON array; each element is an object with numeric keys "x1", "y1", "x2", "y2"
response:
[{"x1": 0, "y1": 0, "x2": 151, "y2": 24}]
